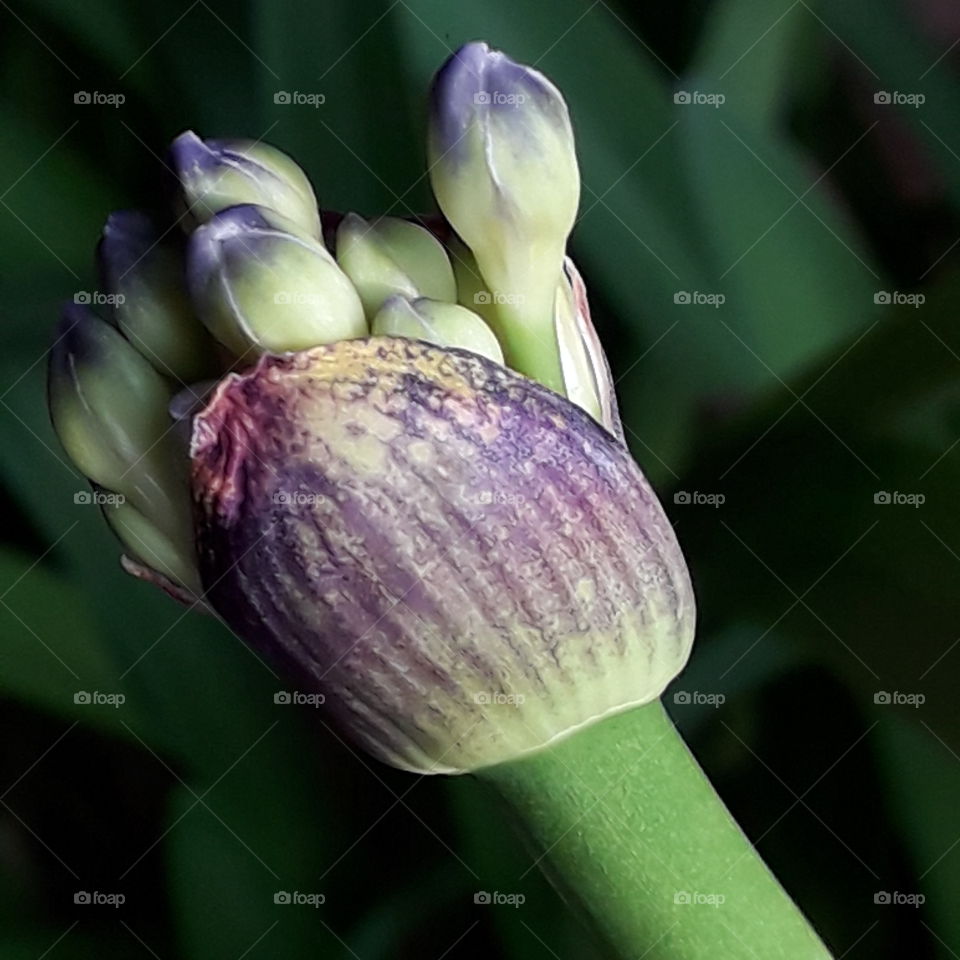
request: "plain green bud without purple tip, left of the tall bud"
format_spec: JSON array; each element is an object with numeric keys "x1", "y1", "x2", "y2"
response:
[{"x1": 337, "y1": 213, "x2": 457, "y2": 320}]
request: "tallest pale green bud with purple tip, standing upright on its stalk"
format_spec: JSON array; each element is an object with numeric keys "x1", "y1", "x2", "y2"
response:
[{"x1": 428, "y1": 43, "x2": 580, "y2": 391}]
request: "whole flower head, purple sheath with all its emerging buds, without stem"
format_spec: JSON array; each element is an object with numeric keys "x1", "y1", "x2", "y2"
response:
[{"x1": 49, "y1": 43, "x2": 693, "y2": 772}]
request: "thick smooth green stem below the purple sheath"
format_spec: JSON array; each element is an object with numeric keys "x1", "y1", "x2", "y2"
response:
[{"x1": 478, "y1": 702, "x2": 830, "y2": 960}]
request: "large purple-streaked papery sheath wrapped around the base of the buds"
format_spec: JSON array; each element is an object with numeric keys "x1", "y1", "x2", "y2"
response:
[{"x1": 191, "y1": 337, "x2": 694, "y2": 773}]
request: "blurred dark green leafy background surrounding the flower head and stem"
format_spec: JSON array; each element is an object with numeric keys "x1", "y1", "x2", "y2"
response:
[{"x1": 0, "y1": 0, "x2": 960, "y2": 960}]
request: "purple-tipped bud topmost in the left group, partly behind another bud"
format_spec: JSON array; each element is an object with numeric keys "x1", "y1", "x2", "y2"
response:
[{"x1": 170, "y1": 130, "x2": 320, "y2": 240}]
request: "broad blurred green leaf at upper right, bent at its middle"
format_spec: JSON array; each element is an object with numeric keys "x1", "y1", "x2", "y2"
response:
[{"x1": 679, "y1": 0, "x2": 882, "y2": 420}]
